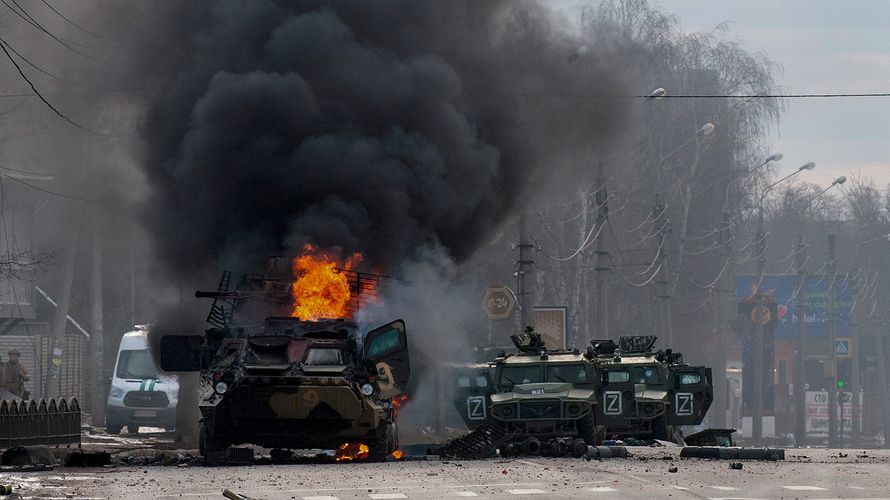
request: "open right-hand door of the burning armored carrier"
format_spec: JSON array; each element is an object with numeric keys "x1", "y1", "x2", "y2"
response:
[{"x1": 362, "y1": 319, "x2": 411, "y2": 399}]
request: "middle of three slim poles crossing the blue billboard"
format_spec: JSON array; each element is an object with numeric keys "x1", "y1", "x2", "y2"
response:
[{"x1": 794, "y1": 232, "x2": 807, "y2": 447}]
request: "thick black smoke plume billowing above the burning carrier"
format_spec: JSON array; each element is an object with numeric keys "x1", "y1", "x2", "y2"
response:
[{"x1": 135, "y1": 0, "x2": 624, "y2": 277}]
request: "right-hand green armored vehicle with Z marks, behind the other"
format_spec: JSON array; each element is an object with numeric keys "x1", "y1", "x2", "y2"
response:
[{"x1": 591, "y1": 336, "x2": 714, "y2": 441}]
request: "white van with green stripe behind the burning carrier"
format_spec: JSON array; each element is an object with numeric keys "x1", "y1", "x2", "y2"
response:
[{"x1": 105, "y1": 325, "x2": 179, "y2": 434}]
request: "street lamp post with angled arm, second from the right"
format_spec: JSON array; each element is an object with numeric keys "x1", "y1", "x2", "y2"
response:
[{"x1": 751, "y1": 162, "x2": 816, "y2": 444}]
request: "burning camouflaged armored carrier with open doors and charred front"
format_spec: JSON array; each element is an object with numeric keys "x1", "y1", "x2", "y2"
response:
[{"x1": 161, "y1": 256, "x2": 410, "y2": 463}]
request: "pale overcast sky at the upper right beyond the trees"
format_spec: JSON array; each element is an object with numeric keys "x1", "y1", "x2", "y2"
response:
[{"x1": 557, "y1": 0, "x2": 890, "y2": 190}]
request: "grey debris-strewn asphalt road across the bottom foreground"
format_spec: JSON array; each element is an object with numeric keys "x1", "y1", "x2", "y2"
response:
[{"x1": 0, "y1": 448, "x2": 890, "y2": 500}]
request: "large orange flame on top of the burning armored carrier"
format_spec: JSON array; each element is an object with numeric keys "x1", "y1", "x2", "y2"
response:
[{"x1": 291, "y1": 243, "x2": 362, "y2": 321}]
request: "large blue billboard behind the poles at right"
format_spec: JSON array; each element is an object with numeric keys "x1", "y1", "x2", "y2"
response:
[{"x1": 735, "y1": 274, "x2": 853, "y2": 339}]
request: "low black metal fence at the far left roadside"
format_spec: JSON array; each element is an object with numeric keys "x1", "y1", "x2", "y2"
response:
[{"x1": 0, "y1": 398, "x2": 80, "y2": 449}]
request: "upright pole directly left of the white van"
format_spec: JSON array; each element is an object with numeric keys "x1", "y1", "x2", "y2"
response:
[{"x1": 90, "y1": 214, "x2": 105, "y2": 427}]
